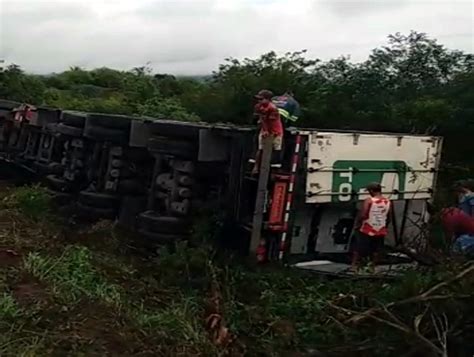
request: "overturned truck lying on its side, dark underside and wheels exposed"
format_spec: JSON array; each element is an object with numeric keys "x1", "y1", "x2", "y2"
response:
[{"x1": 0, "y1": 101, "x2": 442, "y2": 259}]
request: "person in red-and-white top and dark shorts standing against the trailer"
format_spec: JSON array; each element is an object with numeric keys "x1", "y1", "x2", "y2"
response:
[{"x1": 352, "y1": 182, "x2": 391, "y2": 271}]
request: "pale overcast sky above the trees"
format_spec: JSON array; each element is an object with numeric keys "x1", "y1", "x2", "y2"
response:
[{"x1": 0, "y1": 0, "x2": 474, "y2": 75}]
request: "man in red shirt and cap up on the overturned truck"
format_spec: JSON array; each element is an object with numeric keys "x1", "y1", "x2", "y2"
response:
[{"x1": 252, "y1": 89, "x2": 283, "y2": 174}]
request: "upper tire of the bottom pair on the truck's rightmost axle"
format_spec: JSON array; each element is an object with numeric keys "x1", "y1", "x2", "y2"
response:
[{"x1": 137, "y1": 211, "x2": 189, "y2": 234}]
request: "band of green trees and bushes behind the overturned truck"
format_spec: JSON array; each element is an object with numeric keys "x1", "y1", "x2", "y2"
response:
[{"x1": 0, "y1": 32, "x2": 474, "y2": 168}]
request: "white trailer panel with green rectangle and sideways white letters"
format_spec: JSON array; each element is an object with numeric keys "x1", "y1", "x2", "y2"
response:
[{"x1": 306, "y1": 131, "x2": 442, "y2": 203}]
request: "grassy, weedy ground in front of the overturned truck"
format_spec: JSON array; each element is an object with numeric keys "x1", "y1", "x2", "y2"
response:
[{"x1": 0, "y1": 182, "x2": 474, "y2": 356}]
